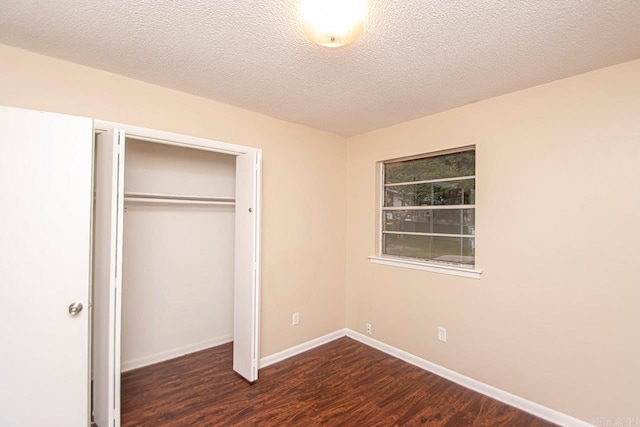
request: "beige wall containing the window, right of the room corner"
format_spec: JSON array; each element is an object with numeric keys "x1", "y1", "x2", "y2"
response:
[{"x1": 347, "y1": 61, "x2": 640, "y2": 421}]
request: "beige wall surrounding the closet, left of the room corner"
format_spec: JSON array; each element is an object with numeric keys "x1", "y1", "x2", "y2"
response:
[{"x1": 0, "y1": 45, "x2": 346, "y2": 356}]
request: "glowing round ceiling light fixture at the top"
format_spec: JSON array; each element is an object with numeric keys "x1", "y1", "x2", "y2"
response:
[{"x1": 301, "y1": 0, "x2": 365, "y2": 47}]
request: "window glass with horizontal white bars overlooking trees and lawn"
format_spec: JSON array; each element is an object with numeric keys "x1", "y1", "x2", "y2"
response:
[{"x1": 379, "y1": 147, "x2": 476, "y2": 269}]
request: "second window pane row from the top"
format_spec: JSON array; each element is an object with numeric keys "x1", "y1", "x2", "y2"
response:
[{"x1": 384, "y1": 179, "x2": 476, "y2": 207}]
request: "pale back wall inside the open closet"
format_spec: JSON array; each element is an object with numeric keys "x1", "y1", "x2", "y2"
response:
[{"x1": 122, "y1": 139, "x2": 235, "y2": 371}]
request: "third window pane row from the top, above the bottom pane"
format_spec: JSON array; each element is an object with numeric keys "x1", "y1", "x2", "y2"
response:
[{"x1": 383, "y1": 209, "x2": 475, "y2": 234}]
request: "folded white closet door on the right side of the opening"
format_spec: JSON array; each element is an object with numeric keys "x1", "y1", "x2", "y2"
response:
[{"x1": 233, "y1": 152, "x2": 261, "y2": 382}]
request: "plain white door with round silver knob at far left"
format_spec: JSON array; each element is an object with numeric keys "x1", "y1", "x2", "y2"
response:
[{"x1": 0, "y1": 107, "x2": 93, "y2": 427}]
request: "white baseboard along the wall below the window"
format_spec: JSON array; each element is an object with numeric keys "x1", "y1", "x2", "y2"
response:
[{"x1": 346, "y1": 329, "x2": 592, "y2": 427}]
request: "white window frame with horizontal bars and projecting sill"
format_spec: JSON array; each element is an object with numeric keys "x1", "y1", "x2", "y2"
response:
[{"x1": 368, "y1": 145, "x2": 482, "y2": 279}]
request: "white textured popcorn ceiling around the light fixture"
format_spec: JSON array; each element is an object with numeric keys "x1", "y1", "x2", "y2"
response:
[{"x1": 0, "y1": 0, "x2": 640, "y2": 136}]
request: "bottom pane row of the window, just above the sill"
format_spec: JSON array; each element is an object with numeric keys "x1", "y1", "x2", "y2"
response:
[{"x1": 382, "y1": 234, "x2": 475, "y2": 265}]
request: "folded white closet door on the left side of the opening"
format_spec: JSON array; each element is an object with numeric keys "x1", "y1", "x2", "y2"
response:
[{"x1": 93, "y1": 130, "x2": 125, "y2": 427}]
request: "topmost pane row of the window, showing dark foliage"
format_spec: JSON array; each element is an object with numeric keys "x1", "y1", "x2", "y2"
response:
[{"x1": 385, "y1": 150, "x2": 476, "y2": 184}]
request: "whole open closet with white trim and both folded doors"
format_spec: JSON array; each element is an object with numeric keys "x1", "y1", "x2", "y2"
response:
[{"x1": 92, "y1": 123, "x2": 261, "y2": 427}]
